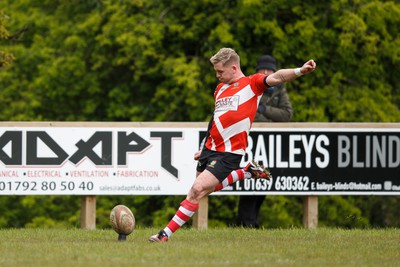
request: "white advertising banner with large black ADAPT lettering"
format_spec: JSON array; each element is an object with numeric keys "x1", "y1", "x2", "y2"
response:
[{"x1": 0, "y1": 127, "x2": 199, "y2": 195}]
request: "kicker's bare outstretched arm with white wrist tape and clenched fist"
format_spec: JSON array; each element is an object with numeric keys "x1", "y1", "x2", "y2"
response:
[{"x1": 267, "y1": 59, "x2": 317, "y2": 86}]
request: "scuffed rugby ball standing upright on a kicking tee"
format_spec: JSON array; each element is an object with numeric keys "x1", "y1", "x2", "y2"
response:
[{"x1": 110, "y1": 205, "x2": 136, "y2": 235}]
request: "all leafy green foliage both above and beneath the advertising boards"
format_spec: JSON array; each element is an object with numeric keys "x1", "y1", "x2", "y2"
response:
[{"x1": 0, "y1": 0, "x2": 400, "y2": 228}]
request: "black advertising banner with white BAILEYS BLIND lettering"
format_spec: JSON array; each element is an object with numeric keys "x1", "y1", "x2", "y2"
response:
[{"x1": 216, "y1": 128, "x2": 400, "y2": 195}]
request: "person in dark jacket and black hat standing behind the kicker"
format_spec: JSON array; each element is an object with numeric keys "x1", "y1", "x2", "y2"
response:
[{"x1": 238, "y1": 55, "x2": 293, "y2": 228}]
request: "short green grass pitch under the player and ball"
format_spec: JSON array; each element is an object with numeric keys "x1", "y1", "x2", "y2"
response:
[{"x1": 0, "y1": 228, "x2": 400, "y2": 267}]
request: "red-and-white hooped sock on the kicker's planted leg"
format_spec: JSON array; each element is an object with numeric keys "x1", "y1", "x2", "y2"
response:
[{"x1": 164, "y1": 199, "x2": 199, "y2": 236}]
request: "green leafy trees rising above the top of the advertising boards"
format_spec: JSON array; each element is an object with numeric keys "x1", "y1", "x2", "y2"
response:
[{"x1": 1, "y1": 0, "x2": 400, "y2": 122}]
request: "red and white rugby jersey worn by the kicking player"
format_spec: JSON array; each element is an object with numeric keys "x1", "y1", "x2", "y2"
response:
[{"x1": 205, "y1": 74, "x2": 267, "y2": 155}]
